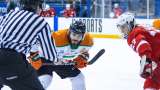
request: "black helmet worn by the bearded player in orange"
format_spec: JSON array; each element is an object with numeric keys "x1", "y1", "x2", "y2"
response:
[{"x1": 67, "y1": 20, "x2": 86, "y2": 41}]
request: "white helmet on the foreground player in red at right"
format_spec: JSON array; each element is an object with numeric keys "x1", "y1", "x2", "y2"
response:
[{"x1": 117, "y1": 12, "x2": 136, "y2": 39}]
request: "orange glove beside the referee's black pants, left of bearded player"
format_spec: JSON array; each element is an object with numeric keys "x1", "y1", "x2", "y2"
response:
[{"x1": 28, "y1": 51, "x2": 42, "y2": 70}]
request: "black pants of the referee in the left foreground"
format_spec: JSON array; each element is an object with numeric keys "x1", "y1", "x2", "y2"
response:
[{"x1": 0, "y1": 48, "x2": 44, "y2": 90}]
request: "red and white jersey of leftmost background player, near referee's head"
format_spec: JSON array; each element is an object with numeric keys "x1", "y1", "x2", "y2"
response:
[{"x1": 41, "y1": 8, "x2": 57, "y2": 17}]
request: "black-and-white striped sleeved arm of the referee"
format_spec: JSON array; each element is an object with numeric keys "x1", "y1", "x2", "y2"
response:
[{"x1": 39, "y1": 23, "x2": 58, "y2": 62}]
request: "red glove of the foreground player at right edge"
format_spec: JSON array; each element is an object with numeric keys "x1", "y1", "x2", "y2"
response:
[{"x1": 140, "y1": 58, "x2": 152, "y2": 79}]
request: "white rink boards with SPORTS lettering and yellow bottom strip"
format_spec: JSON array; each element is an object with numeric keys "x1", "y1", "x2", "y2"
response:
[{"x1": 0, "y1": 17, "x2": 155, "y2": 39}]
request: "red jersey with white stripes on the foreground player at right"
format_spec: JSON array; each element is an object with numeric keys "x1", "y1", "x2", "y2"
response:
[{"x1": 127, "y1": 26, "x2": 160, "y2": 63}]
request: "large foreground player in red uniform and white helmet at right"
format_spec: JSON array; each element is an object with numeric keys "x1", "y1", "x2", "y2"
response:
[{"x1": 117, "y1": 12, "x2": 160, "y2": 90}]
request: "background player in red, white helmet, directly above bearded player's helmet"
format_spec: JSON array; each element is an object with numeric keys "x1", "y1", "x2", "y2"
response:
[{"x1": 62, "y1": 4, "x2": 76, "y2": 18}]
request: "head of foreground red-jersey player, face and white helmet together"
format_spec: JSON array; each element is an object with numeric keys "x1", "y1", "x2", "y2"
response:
[{"x1": 117, "y1": 12, "x2": 136, "y2": 39}]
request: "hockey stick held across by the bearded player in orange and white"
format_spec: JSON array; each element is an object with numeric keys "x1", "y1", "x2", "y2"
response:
[{"x1": 42, "y1": 49, "x2": 105, "y2": 66}]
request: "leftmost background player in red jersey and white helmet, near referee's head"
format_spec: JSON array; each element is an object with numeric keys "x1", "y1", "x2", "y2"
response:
[{"x1": 41, "y1": 4, "x2": 57, "y2": 17}]
